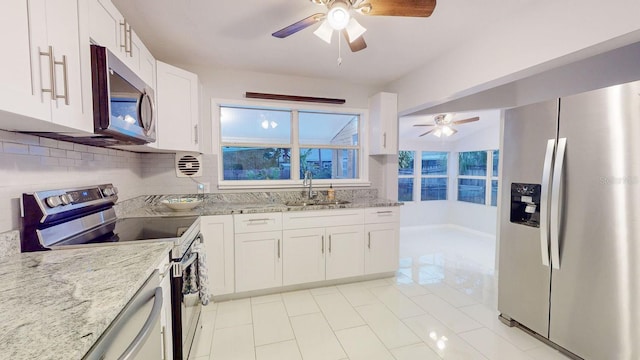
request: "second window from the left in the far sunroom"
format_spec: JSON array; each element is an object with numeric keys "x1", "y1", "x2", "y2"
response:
[{"x1": 420, "y1": 151, "x2": 449, "y2": 201}]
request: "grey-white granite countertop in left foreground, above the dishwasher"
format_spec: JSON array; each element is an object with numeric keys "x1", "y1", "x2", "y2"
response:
[{"x1": 0, "y1": 243, "x2": 171, "y2": 360}]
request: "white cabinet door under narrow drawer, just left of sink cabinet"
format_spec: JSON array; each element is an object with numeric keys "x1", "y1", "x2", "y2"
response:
[{"x1": 235, "y1": 231, "x2": 282, "y2": 292}]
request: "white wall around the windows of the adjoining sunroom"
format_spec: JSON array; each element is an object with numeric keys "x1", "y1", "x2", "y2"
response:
[{"x1": 400, "y1": 110, "x2": 501, "y2": 235}]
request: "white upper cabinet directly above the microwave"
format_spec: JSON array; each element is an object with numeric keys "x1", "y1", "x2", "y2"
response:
[{"x1": 89, "y1": 0, "x2": 155, "y2": 87}]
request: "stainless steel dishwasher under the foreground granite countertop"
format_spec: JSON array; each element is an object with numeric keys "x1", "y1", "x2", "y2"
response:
[{"x1": 83, "y1": 270, "x2": 163, "y2": 360}]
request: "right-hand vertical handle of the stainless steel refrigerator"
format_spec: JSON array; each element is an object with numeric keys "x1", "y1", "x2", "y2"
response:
[{"x1": 549, "y1": 138, "x2": 567, "y2": 269}]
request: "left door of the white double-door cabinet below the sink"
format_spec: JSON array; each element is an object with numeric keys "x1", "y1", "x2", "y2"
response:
[{"x1": 282, "y1": 228, "x2": 326, "y2": 286}]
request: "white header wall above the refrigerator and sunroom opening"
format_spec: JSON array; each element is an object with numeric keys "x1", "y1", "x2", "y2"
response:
[{"x1": 385, "y1": 0, "x2": 640, "y2": 113}]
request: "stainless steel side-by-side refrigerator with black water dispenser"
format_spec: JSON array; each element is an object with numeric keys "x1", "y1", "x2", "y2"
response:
[{"x1": 498, "y1": 82, "x2": 640, "y2": 360}]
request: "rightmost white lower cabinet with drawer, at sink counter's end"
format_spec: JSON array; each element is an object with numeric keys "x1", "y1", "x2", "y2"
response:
[{"x1": 364, "y1": 208, "x2": 400, "y2": 274}]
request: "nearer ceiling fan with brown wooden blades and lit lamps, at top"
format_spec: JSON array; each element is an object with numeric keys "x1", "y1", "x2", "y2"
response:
[{"x1": 271, "y1": 0, "x2": 436, "y2": 52}]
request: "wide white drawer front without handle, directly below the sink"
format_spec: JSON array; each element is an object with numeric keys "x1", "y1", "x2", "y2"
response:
[{"x1": 282, "y1": 209, "x2": 364, "y2": 230}]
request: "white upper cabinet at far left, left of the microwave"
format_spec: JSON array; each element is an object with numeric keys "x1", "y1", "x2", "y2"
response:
[{"x1": 0, "y1": 0, "x2": 93, "y2": 132}]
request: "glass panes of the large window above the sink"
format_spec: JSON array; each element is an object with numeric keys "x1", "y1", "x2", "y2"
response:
[{"x1": 220, "y1": 105, "x2": 362, "y2": 184}]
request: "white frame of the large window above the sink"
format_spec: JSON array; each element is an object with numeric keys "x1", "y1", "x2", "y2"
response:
[{"x1": 211, "y1": 99, "x2": 371, "y2": 190}]
